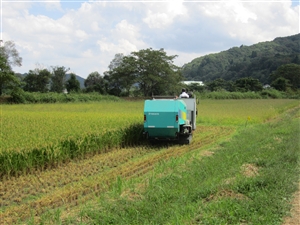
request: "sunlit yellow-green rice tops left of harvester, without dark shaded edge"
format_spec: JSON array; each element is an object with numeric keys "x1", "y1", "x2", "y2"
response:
[{"x1": 0, "y1": 102, "x2": 143, "y2": 151}]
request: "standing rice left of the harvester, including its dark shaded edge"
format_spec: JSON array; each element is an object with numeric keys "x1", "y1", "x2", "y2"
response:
[{"x1": 0, "y1": 102, "x2": 143, "y2": 177}]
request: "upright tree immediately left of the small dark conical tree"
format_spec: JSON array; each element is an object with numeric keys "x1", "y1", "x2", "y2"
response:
[{"x1": 51, "y1": 66, "x2": 70, "y2": 93}]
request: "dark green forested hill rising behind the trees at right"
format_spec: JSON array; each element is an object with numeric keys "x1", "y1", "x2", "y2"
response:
[{"x1": 182, "y1": 34, "x2": 300, "y2": 83}]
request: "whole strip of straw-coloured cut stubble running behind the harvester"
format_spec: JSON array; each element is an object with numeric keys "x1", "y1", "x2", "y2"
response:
[{"x1": 0, "y1": 127, "x2": 234, "y2": 224}]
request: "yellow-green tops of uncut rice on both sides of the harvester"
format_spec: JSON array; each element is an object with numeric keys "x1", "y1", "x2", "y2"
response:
[{"x1": 0, "y1": 99, "x2": 298, "y2": 152}]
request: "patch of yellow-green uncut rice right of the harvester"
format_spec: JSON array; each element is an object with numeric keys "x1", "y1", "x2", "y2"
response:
[{"x1": 197, "y1": 99, "x2": 299, "y2": 126}]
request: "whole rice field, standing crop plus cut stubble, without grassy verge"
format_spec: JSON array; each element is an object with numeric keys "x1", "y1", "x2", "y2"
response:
[{"x1": 0, "y1": 99, "x2": 300, "y2": 224}]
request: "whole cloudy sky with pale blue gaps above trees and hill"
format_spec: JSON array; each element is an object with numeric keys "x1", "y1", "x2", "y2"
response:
[{"x1": 0, "y1": 0, "x2": 300, "y2": 78}]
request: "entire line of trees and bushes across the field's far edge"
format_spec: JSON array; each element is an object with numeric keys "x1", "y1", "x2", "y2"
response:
[{"x1": 0, "y1": 41, "x2": 300, "y2": 101}]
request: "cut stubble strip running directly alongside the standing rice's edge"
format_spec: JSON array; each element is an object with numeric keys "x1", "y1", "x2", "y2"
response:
[{"x1": 0, "y1": 148, "x2": 146, "y2": 207}]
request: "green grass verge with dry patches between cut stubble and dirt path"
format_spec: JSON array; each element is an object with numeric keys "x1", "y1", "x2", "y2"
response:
[{"x1": 67, "y1": 104, "x2": 299, "y2": 225}]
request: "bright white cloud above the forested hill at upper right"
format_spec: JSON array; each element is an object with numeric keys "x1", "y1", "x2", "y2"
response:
[{"x1": 199, "y1": 0, "x2": 299, "y2": 43}]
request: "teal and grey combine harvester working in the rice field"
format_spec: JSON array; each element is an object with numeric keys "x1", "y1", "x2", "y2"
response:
[{"x1": 143, "y1": 96, "x2": 197, "y2": 144}]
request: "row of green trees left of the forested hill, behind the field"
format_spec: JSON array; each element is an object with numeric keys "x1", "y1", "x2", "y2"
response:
[{"x1": 0, "y1": 41, "x2": 183, "y2": 96}]
